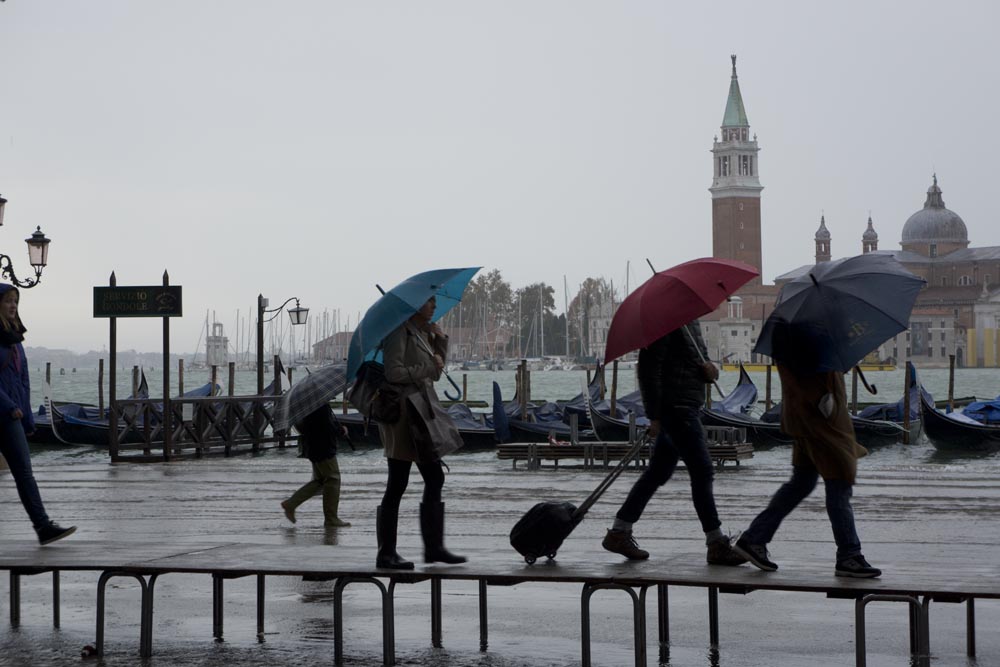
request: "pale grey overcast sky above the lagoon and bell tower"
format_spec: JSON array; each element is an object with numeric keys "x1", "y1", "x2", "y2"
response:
[{"x1": 0, "y1": 0, "x2": 1000, "y2": 352}]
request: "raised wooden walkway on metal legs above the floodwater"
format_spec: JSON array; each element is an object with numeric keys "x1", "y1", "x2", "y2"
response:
[{"x1": 0, "y1": 540, "x2": 1000, "y2": 666}]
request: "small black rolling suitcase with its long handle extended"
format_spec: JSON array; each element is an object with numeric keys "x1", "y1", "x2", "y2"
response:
[{"x1": 510, "y1": 440, "x2": 646, "y2": 565}]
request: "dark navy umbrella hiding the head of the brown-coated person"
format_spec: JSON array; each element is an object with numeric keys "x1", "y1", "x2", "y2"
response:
[{"x1": 754, "y1": 253, "x2": 925, "y2": 373}]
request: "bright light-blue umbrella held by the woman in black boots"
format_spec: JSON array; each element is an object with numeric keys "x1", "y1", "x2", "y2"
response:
[{"x1": 347, "y1": 266, "x2": 480, "y2": 381}]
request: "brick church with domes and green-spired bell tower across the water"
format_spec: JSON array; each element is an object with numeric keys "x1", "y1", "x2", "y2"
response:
[{"x1": 702, "y1": 56, "x2": 1000, "y2": 368}]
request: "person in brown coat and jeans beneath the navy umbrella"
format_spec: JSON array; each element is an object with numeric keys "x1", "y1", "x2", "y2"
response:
[{"x1": 733, "y1": 321, "x2": 882, "y2": 578}]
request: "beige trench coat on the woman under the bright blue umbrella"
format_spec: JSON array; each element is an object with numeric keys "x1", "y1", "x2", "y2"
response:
[{"x1": 378, "y1": 321, "x2": 448, "y2": 463}]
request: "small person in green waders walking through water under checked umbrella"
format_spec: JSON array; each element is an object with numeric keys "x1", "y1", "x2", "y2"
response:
[{"x1": 281, "y1": 403, "x2": 351, "y2": 528}]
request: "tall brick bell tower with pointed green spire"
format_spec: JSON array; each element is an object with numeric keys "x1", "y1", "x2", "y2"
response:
[{"x1": 708, "y1": 55, "x2": 764, "y2": 285}]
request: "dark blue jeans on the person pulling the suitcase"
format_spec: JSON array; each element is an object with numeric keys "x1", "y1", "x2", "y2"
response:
[{"x1": 617, "y1": 407, "x2": 722, "y2": 533}]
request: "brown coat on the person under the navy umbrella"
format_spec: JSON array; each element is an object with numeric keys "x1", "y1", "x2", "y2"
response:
[{"x1": 778, "y1": 363, "x2": 868, "y2": 484}]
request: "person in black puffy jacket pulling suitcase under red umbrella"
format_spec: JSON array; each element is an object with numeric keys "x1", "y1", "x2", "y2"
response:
[{"x1": 603, "y1": 320, "x2": 746, "y2": 565}]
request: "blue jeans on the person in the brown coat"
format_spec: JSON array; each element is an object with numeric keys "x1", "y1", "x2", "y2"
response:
[{"x1": 741, "y1": 466, "x2": 861, "y2": 560}]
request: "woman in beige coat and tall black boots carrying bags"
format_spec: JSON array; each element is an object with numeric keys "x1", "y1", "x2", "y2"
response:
[{"x1": 375, "y1": 297, "x2": 466, "y2": 570}]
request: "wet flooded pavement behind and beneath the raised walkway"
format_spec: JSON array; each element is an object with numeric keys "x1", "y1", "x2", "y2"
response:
[{"x1": 0, "y1": 443, "x2": 1000, "y2": 667}]
